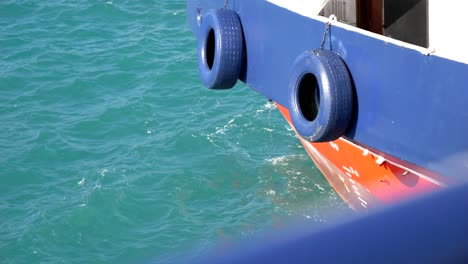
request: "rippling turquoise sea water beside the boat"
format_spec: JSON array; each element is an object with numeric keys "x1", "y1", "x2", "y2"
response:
[{"x1": 0, "y1": 0, "x2": 348, "y2": 264}]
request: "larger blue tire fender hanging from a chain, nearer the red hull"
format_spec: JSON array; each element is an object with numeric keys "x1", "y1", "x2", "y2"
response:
[{"x1": 289, "y1": 50, "x2": 353, "y2": 142}]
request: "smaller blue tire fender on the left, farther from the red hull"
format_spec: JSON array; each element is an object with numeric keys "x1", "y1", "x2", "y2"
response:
[{"x1": 198, "y1": 8, "x2": 244, "y2": 89}]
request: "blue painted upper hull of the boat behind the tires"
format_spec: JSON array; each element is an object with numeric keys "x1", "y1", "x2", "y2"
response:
[{"x1": 187, "y1": 0, "x2": 468, "y2": 179}]
